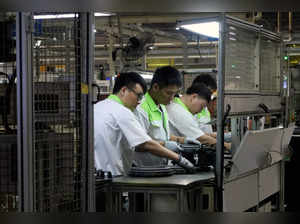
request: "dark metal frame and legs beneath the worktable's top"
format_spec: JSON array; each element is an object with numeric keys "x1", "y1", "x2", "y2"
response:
[{"x1": 107, "y1": 178, "x2": 214, "y2": 213}]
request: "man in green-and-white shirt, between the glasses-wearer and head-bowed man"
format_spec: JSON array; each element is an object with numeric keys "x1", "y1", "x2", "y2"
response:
[{"x1": 134, "y1": 66, "x2": 200, "y2": 166}]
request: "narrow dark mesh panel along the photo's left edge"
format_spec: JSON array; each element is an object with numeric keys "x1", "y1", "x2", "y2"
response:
[{"x1": 0, "y1": 13, "x2": 18, "y2": 212}]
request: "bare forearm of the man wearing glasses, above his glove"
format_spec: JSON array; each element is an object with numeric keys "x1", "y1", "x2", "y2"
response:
[{"x1": 136, "y1": 140, "x2": 179, "y2": 161}]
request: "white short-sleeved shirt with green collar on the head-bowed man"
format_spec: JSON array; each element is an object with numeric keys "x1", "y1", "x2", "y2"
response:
[{"x1": 167, "y1": 98, "x2": 204, "y2": 139}]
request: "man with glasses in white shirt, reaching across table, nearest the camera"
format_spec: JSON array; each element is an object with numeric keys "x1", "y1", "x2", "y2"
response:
[{"x1": 94, "y1": 72, "x2": 194, "y2": 176}]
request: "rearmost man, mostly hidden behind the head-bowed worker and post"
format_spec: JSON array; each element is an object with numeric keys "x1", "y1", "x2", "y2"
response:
[{"x1": 192, "y1": 74, "x2": 231, "y2": 142}]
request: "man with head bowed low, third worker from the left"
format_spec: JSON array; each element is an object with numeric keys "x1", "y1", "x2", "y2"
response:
[{"x1": 167, "y1": 83, "x2": 231, "y2": 150}]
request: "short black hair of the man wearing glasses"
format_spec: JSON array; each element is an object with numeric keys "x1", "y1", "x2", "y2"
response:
[{"x1": 113, "y1": 72, "x2": 147, "y2": 94}]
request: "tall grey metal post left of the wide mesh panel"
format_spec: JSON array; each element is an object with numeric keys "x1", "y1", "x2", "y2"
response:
[{"x1": 16, "y1": 12, "x2": 34, "y2": 212}]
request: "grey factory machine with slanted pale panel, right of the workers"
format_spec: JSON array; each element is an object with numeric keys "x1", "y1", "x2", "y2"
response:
[{"x1": 218, "y1": 17, "x2": 294, "y2": 212}]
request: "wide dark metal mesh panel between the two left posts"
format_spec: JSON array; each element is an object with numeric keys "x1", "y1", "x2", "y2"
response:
[{"x1": 33, "y1": 14, "x2": 85, "y2": 212}]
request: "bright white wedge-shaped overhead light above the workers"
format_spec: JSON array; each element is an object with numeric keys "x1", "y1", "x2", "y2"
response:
[{"x1": 180, "y1": 21, "x2": 219, "y2": 38}]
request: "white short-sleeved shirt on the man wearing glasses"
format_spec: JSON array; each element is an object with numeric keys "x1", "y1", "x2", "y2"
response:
[{"x1": 94, "y1": 95, "x2": 151, "y2": 175}]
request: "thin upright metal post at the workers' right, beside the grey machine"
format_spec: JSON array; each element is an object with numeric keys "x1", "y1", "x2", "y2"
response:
[{"x1": 216, "y1": 13, "x2": 225, "y2": 212}]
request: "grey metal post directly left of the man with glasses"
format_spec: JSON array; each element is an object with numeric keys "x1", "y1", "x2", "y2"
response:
[{"x1": 80, "y1": 12, "x2": 95, "y2": 212}]
